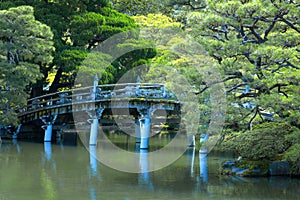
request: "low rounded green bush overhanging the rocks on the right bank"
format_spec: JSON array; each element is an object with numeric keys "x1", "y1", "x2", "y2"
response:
[{"x1": 219, "y1": 122, "x2": 300, "y2": 161}]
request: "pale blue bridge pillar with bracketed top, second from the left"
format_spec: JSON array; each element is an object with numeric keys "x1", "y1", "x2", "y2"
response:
[{"x1": 88, "y1": 108, "x2": 104, "y2": 146}]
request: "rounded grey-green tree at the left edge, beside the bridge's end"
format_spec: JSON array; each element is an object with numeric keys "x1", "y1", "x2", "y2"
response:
[{"x1": 0, "y1": 6, "x2": 54, "y2": 125}]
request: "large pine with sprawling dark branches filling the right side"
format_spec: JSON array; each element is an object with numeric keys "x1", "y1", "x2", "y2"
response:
[{"x1": 187, "y1": 0, "x2": 300, "y2": 129}]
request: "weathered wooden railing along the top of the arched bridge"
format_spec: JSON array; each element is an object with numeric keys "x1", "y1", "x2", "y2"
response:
[{"x1": 19, "y1": 83, "x2": 175, "y2": 113}]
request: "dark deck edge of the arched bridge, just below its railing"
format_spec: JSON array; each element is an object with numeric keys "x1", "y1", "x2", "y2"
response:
[{"x1": 19, "y1": 99, "x2": 180, "y2": 124}]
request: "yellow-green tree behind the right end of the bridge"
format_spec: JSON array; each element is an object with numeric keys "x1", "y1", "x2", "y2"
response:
[{"x1": 134, "y1": 14, "x2": 220, "y2": 134}]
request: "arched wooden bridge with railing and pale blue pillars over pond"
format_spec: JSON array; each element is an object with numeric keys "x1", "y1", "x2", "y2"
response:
[{"x1": 18, "y1": 77, "x2": 181, "y2": 148}]
